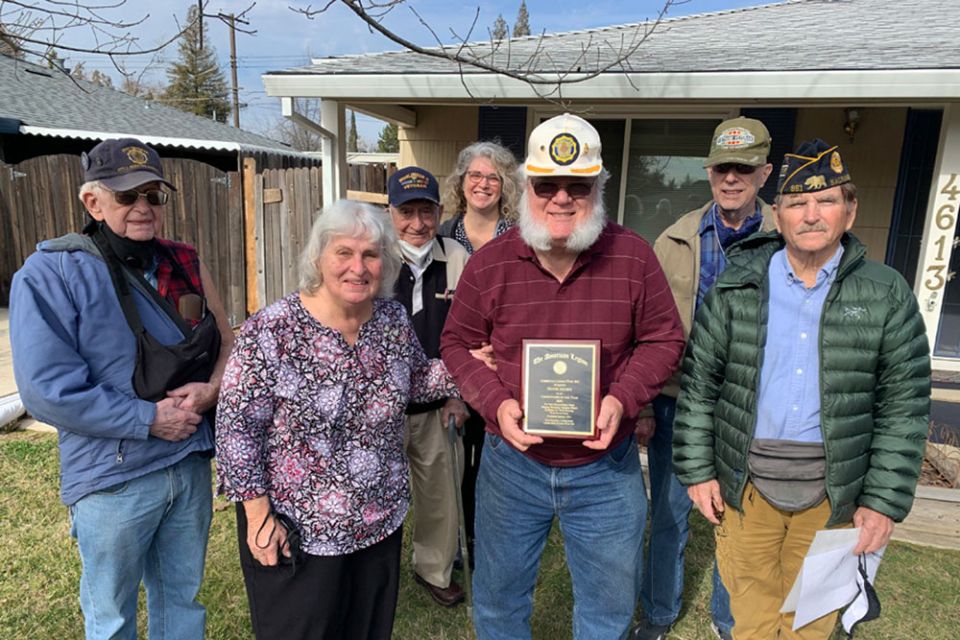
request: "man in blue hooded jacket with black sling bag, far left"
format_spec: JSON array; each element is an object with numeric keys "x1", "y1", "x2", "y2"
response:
[{"x1": 10, "y1": 138, "x2": 233, "y2": 639}]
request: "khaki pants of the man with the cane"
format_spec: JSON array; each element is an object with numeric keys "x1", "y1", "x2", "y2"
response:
[{"x1": 404, "y1": 409, "x2": 463, "y2": 589}]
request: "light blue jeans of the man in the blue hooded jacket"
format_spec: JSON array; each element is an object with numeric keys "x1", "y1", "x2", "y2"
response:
[{"x1": 70, "y1": 455, "x2": 213, "y2": 640}]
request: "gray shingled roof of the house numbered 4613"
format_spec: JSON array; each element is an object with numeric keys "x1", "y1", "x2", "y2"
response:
[{"x1": 267, "y1": 0, "x2": 960, "y2": 75}]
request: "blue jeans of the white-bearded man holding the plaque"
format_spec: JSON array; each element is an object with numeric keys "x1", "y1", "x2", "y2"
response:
[{"x1": 473, "y1": 434, "x2": 647, "y2": 640}]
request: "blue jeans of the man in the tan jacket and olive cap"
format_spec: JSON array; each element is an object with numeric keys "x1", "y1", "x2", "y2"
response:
[{"x1": 640, "y1": 395, "x2": 733, "y2": 633}]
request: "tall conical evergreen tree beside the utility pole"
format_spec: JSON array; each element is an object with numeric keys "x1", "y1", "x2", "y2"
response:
[{"x1": 161, "y1": 6, "x2": 230, "y2": 122}]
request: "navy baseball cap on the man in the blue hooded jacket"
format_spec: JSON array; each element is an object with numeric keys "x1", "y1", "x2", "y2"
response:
[{"x1": 80, "y1": 138, "x2": 177, "y2": 191}]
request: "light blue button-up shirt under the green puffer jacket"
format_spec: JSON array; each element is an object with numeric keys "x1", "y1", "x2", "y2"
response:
[{"x1": 754, "y1": 245, "x2": 843, "y2": 442}]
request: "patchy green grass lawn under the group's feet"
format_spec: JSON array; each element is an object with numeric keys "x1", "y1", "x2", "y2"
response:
[{"x1": 0, "y1": 433, "x2": 960, "y2": 640}]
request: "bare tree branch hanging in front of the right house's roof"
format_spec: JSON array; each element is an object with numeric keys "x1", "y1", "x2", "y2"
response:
[{"x1": 290, "y1": 0, "x2": 689, "y2": 101}]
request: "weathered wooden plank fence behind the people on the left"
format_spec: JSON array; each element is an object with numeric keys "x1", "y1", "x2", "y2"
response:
[{"x1": 0, "y1": 154, "x2": 387, "y2": 325}]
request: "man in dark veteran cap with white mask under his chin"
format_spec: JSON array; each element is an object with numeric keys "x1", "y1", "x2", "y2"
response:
[{"x1": 387, "y1": 167, "x2": 468, "y2": 607}]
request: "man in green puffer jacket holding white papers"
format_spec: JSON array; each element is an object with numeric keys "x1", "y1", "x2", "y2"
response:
[{"x1": 673, "y1": 140, "x2": 930, "y2": 640}]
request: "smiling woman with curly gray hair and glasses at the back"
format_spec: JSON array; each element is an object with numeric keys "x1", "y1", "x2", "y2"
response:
[{"x1": 439, "y1": 141, "x2": 520, "y2": 254}]
